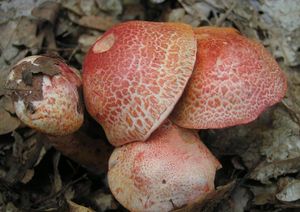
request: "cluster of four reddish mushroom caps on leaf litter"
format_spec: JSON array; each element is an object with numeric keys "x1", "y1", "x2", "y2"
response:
[{"x1": 7, "y1": 21, "x2": 287, "y2": 211}]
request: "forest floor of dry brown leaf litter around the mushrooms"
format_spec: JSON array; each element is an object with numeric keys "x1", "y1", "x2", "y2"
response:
[{"x1": 0, "y1": 0, "x2": 300, "y2": 212}]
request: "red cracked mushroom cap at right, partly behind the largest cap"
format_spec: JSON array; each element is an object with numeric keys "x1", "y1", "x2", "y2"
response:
[{"x1": 170, "y1": 27, "x2": 287, "y2": 129}]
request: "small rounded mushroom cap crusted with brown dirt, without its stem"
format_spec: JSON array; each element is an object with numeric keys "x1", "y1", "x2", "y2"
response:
[{"x1": 6, "y1": 56, "x2": 83, "y2": 136}]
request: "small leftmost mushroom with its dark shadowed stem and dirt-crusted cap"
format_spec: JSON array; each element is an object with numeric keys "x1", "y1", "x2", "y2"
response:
[{"x1": 6, "y1": 56, "x2": 110, "y2": 172}]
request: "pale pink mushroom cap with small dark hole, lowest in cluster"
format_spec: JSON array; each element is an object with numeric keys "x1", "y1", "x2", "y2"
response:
[{"x1": 108, "y1": 120, "x2": 221, "y2": 211}]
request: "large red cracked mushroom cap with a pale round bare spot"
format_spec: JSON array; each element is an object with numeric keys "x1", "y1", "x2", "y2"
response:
[{"x1": 83, "y1": 21, "x2": 197, "y2": 146}]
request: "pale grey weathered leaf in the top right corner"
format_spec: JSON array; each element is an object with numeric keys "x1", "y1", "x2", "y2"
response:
[{"x1": 259, "y1": 0, "x2": 300, "y2": 66}]
